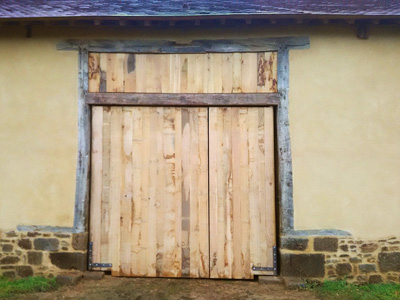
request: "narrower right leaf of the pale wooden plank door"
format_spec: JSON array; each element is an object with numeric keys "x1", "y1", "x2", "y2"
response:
[{"x1": 209, "y1": 107, "x2": 276, "y2": 279}]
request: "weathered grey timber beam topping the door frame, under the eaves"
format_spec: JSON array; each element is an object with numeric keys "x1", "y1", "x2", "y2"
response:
[{"x1": 57, "y1": 36, "x2": 310, "y2": 53}]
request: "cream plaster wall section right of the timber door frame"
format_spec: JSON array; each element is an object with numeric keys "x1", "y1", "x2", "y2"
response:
[{"x1": 290, "y1": 27, "x2": 400, "y2": 238}]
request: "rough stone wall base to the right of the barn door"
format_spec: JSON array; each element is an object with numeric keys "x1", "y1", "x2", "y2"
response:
[{"x1": 280, "y1": 236, "x2": 400, "y2": 284}]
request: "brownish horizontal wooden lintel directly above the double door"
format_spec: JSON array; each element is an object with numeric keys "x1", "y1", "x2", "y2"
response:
[{"x1": 86, "y1": 93, "x2": 280, "y2": 106}]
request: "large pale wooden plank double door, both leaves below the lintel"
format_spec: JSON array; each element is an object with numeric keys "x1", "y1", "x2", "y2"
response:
[{"x1": 90, "y1": 106, "x2": 276, "y2": 279}]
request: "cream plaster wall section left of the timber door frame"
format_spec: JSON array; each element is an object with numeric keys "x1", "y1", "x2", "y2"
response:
[{"x1": 0, "y1": 30, "x2": 78, "y2": 230}]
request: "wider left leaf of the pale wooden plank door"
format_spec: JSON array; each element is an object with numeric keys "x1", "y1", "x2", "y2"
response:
[{"x1": 90, "y1": 106, "x2": 209, "y2": 277}]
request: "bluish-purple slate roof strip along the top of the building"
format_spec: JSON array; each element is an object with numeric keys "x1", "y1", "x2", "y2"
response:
[{"x1": 0, "y1": 0, "x2": 400, "y2": 18}]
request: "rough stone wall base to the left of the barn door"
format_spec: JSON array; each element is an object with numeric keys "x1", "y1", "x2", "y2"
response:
[{"x1": 0, "y1": 231, "x2": 88, "y2": 278}]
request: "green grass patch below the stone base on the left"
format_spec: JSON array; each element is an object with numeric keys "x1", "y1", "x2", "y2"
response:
[{"x1": 0, "y1": 277, "x2": 57, "y2": 298}]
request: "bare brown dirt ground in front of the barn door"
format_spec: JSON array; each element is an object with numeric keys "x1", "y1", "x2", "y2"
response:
[{"x1": 15, "y1": 276, "x2": 317, "y2": 300}]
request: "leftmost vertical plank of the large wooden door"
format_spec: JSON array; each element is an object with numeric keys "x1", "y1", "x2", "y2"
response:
[{"x1": 90, "y1": 106, "x2": 103, "y2": 262}]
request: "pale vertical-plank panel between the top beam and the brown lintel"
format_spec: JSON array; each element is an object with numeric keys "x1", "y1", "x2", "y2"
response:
[{"x1": 89, "y1": 52, "x2": 277, "y2": 93}]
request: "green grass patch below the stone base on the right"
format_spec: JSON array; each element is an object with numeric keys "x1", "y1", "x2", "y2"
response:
[{"x1": 307, "y1": 281, "x2": 400, "y2": 300}]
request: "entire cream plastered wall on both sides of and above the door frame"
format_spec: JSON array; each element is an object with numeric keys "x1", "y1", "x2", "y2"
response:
[{"x1": 0, "y1": 26, "x2": 400, "y2": 238}]
